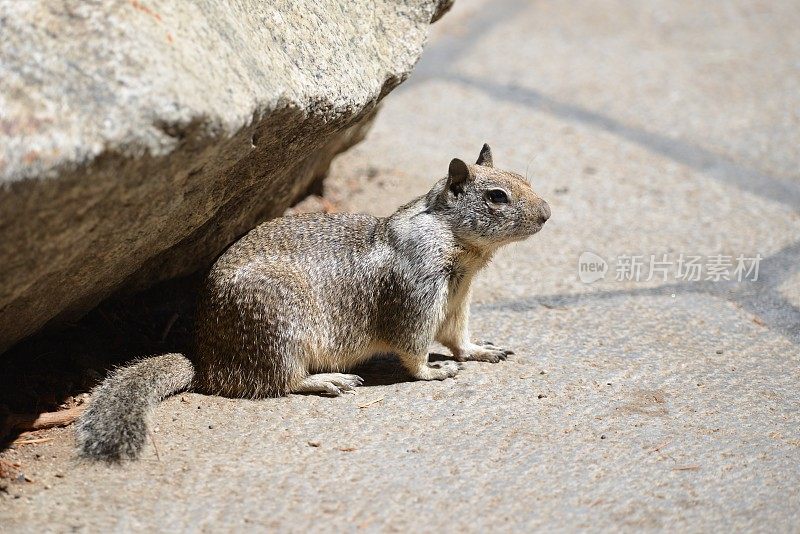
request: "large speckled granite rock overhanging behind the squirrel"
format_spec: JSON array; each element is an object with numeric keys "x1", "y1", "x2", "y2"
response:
[{"x1": 0, "y1": 0, "x2": 451, "y2": 351}]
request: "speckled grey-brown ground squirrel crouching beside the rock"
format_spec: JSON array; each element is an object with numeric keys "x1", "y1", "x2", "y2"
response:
[{"x1": 77, "y1": 145, "x2": 550, "y2": 461}]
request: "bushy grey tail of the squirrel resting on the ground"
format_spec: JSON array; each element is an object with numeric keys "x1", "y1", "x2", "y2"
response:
[{"x1": 76, "y1": 354, "x2": 194, "y2": 462}]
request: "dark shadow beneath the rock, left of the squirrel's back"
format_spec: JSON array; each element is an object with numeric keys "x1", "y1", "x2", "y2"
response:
[{"x1": 0, "y1": 273, "x2": 203, "y2": 450}]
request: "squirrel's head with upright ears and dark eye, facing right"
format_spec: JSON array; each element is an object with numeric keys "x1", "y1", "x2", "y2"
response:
[{"x1": 428, "y1": 145, "x2": 550, "y2": 250}]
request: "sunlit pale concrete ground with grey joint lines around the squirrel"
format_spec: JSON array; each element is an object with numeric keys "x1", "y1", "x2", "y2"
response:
[{"x1": 0, "y1": 0, "x2": 800, "y2": 532}]
